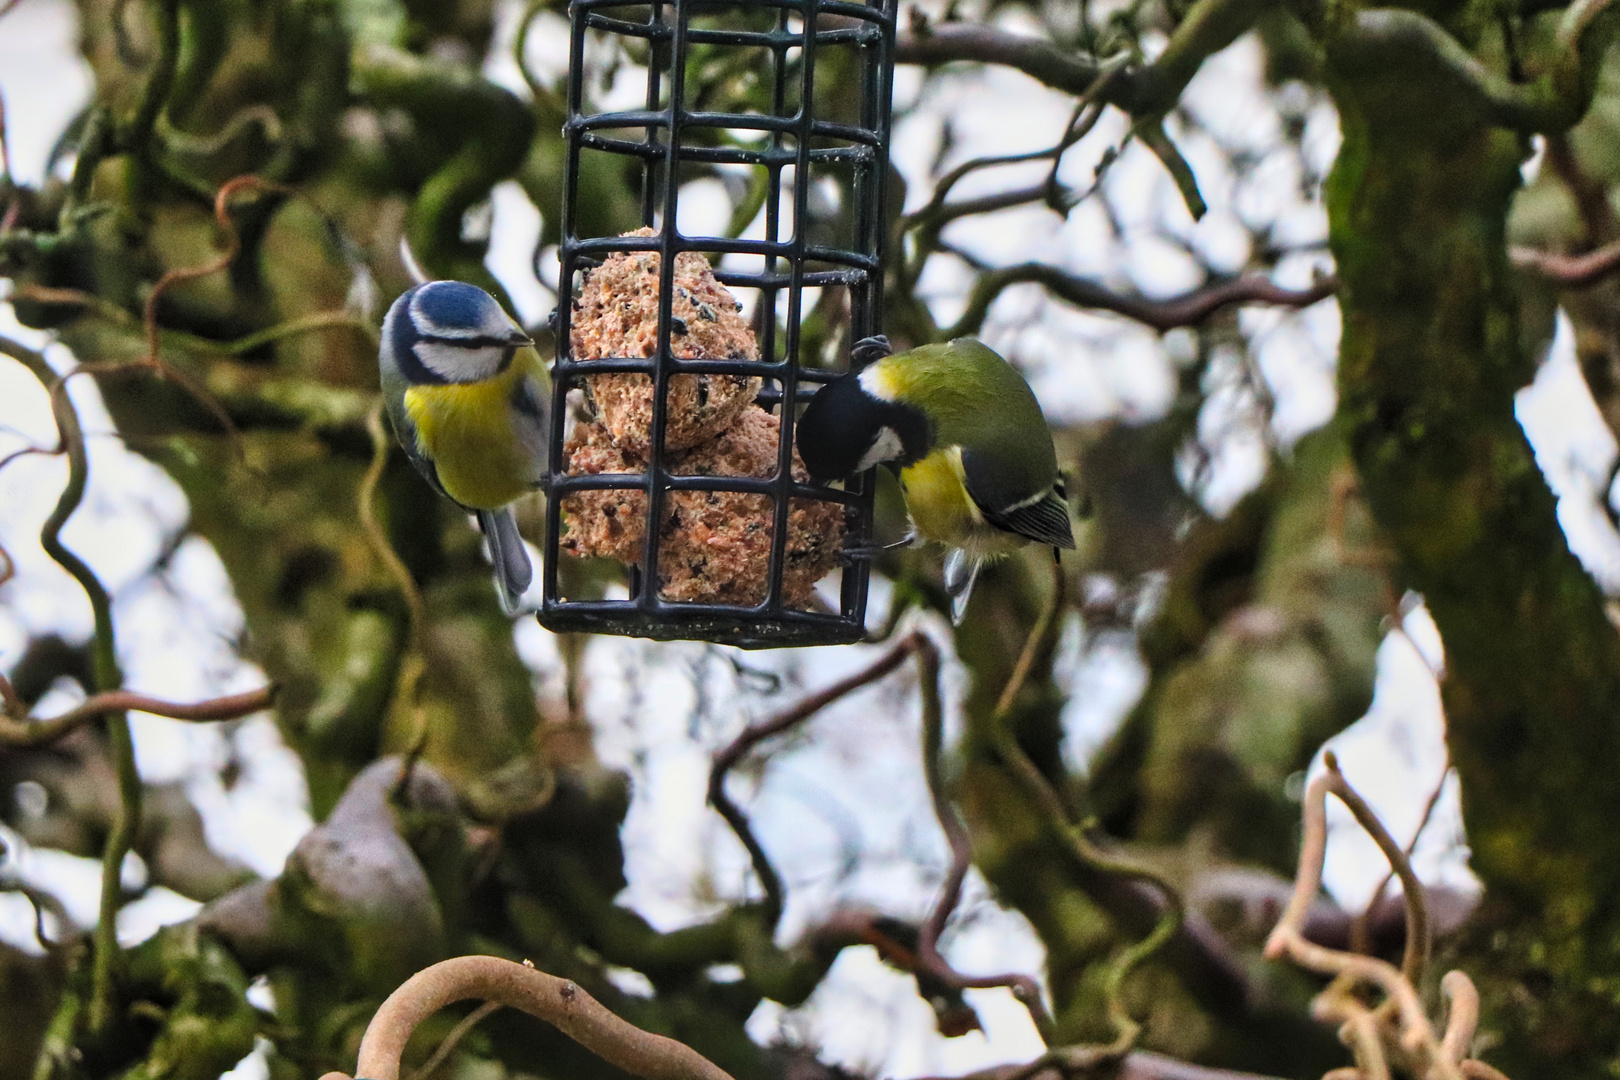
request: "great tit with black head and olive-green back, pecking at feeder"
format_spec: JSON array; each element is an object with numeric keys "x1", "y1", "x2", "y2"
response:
[{"x1": 797, "y1": 337, "x2": 1074, "y2": 623}]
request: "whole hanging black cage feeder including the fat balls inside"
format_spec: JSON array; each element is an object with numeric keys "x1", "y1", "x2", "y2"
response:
[{"x1": 539, "y1": 0, "x2": 897, "y2": 648}]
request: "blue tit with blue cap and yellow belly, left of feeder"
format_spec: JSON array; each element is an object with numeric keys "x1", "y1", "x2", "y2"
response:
[{"x1": 377, "y1": 282, "x2": 551, "y2": 615}]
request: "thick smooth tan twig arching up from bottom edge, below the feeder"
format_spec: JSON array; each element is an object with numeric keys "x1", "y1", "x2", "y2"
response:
[{"x1": 321, "y1": 957, "x2": 732, "y2": 1080}]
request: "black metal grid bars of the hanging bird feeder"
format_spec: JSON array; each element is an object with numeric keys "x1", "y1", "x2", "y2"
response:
[{"x1": 539, "y1": 0, "x2": 897, "y2": 648}]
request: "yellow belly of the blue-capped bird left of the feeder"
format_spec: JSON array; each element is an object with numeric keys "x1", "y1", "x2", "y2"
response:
[{"x1": 405, "y1": 363, "x2": 535, "y2": 510}]
